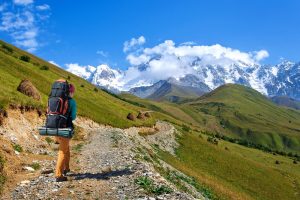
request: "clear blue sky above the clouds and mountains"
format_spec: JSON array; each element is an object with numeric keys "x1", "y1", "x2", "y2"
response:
[{"x1": 0, "y1": 0, "x2": 300, "y2": 69}]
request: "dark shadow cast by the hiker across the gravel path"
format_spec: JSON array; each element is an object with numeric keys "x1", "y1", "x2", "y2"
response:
[{"x1": 69, "y1": 169, "x2": 134, "y2": 180}]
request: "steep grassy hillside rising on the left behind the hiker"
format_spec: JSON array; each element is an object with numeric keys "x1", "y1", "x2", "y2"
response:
[{"x1": 0, "y1": 41, "x2": 178, "y2": 127}]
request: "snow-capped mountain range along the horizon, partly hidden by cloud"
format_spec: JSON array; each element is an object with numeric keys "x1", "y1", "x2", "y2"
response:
[{"x1": 68, "y1": 57, "x2": 300, "y2": 100}]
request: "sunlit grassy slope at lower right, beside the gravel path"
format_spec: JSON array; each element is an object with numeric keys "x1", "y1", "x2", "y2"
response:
[{"x1": 159, "y1": 130, "x2": 300, "y2": 200}]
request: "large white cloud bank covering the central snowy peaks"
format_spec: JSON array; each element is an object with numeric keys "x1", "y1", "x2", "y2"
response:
[{"x1": 119, "y1": 40, "x2": 269, "y2": 89}]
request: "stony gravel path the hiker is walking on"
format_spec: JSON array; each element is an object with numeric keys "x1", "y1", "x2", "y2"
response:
[{"x1": 5, "y1": 123, "x2": 200, "y2": 200}]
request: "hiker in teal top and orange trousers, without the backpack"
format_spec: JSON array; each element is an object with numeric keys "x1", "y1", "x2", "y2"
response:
[{"x1": 55, "y1": 84, "x2": 77, "y2": 182}]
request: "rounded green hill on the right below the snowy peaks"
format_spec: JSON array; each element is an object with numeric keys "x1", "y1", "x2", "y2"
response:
[{"x1": 183, "y1": 84, "x2": 300, "y2": 152}]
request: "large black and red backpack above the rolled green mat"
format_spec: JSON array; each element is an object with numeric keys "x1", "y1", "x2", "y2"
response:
[{"x1": 46, "y1": 80, "x2": 69, "y2": 128}]
